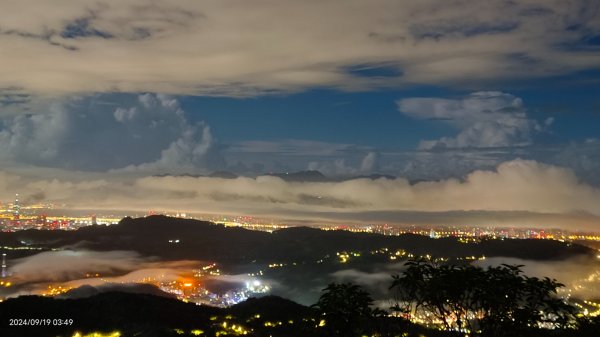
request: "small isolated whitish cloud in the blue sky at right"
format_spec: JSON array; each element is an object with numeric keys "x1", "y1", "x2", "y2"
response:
[{"x1": 397, "y1": 91, "x2": 553, "y2": 150}]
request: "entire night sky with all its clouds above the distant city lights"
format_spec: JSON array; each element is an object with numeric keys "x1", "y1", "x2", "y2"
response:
[{"x1": 0, "y1": 0, "x2": 600, "y2": 226}]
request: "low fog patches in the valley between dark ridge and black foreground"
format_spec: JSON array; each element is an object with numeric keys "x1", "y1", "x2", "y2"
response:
[{"x1": 0, "y1": 250, "x2": 600, "y2": 307}]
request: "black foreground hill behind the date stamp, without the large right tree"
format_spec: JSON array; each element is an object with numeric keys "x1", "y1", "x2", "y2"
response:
[{"x1": 0, "y1": 292, "x2": 599, "y2": 337}]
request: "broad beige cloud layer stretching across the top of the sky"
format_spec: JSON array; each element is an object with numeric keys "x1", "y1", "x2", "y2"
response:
[{"x1": 0, "y1": 0, "x2": 600, "y2": 96}]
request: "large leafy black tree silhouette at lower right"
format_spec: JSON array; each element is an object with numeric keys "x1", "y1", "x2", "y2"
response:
[{"x1": 391, "y1": 260, "x2": 574, "y2": 337}]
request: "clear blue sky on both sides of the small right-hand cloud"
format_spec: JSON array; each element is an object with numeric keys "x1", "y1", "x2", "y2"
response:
[{"x1": 181, "y1": 79, "x2": 600, "y2": 149}]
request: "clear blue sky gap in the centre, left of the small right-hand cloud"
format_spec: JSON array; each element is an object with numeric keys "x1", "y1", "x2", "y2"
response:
[{"x1": 182, "y1": 87, "x2": 452, "y2": 149}]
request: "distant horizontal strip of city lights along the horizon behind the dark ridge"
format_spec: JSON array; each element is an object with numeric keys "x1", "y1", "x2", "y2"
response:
[{"x1": 0, "y1": 194, "x2": 600, "y2": 243}]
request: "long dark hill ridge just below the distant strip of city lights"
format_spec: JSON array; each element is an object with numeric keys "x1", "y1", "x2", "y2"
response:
[{"x1": 0, "y1": 216, "x2": 593, "y2": 264}]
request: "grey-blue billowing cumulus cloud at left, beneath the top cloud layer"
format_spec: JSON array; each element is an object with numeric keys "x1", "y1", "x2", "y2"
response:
[{"x1": 0, "y1": 94, "x2": 223, "y2": 173}]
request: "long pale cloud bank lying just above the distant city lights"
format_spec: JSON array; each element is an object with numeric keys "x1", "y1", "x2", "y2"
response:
[{"x1": 0, "y1": 160, "x2": 600, "y2": 227}]
